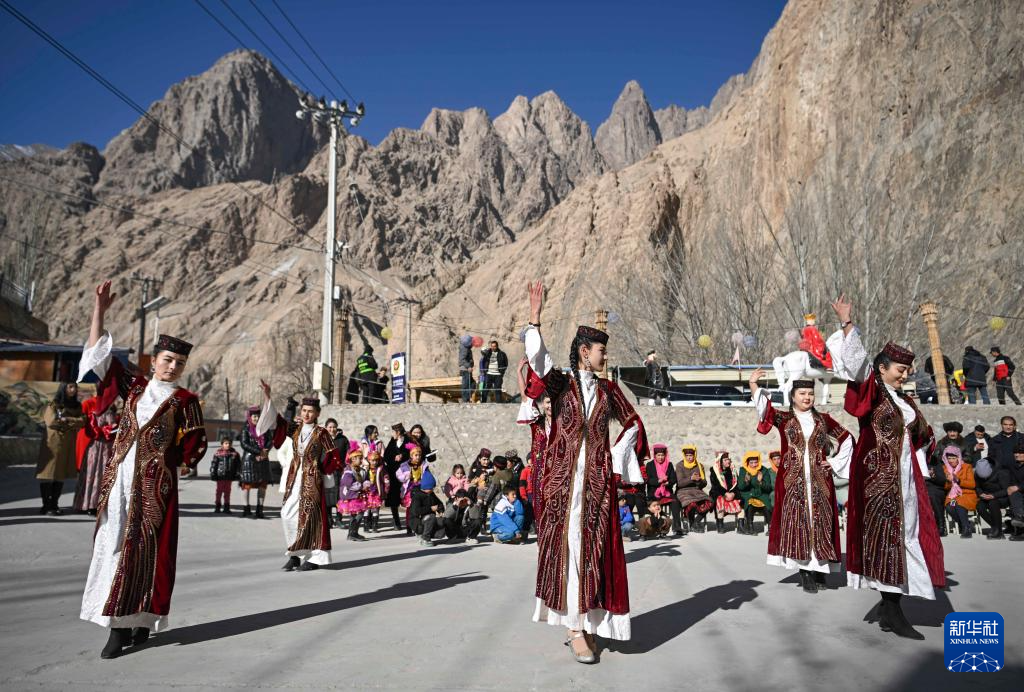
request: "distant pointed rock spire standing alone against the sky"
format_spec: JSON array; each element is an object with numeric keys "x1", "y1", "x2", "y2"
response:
[{"x1": 595, "y1": 81, "x2": 662, "y2": 170}]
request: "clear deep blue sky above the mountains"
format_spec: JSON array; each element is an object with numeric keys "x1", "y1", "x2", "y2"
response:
[{"x1": 0, "y1": 0, "x2": 785, "y2": 148}]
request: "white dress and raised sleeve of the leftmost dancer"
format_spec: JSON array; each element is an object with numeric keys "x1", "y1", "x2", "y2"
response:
[{"x1": 78, "y1": 332, "x2": 178, "y2": 632}]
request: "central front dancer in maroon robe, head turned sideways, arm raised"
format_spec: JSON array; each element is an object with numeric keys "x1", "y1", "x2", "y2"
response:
[{"x1": 525, "y1": 284, "x2": 648, "y2": 663}]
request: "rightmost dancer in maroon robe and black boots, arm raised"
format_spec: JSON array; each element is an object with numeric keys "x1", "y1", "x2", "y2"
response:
[{"x1": 828, "y1": 296, "x2": 946, "y2": 640}]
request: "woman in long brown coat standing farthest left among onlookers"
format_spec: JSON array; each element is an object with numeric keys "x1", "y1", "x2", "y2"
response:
[{"x1": 36, "y1": 382, "x2": 86, "y2": 517}]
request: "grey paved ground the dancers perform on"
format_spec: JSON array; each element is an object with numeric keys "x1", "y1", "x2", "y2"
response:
[{"x1": 0, "y1": 448, "x2": 1024, "y2": 692}]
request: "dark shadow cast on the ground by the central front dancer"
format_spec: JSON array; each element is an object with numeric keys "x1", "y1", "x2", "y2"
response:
[{"x1": 606, "y1": 579, "x2": 762, "y2": 654}]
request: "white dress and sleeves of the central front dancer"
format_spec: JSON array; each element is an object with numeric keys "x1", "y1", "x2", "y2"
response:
[{"x1": 526, "y1": 327, "x2": 643, "y2": 640}]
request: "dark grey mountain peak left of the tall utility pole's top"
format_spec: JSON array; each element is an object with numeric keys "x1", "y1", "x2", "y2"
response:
[{"x1": 100, "y1": 50, "x2": 328, "y2": 193}]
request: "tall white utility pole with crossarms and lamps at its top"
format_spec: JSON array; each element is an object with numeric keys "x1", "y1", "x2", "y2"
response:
[{"x1": 295, "y1": 94, "x2": 366, "y2": 403}]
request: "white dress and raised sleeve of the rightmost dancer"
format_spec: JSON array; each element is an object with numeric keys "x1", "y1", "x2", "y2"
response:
[{"x1": 827, "y1": 329, "x2": 935, "y2": 601}]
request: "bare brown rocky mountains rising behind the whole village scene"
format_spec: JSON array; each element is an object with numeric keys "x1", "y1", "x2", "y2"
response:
[{"x1": 0, "y1": 0, "x2": 1024, "y2": 410}]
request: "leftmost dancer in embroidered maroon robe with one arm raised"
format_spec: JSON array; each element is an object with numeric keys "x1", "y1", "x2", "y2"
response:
[{"x1": 79, "y1": 282, "x2": 206, "y2": 658}]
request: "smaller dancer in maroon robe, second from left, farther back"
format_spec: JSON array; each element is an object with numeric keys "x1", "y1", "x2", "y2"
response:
[{"x1": 256, "y1": 380, "x2": 342, "y2": 572}]
